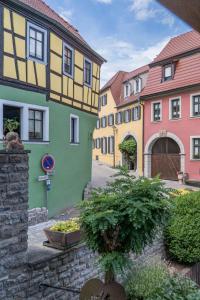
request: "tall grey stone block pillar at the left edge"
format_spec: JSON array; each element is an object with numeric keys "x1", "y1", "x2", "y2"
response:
[{"x1": 0, "y1": 150, "x2": 28, "y2": 299}]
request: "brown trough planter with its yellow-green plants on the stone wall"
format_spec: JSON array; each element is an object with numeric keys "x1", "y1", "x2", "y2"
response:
[{"x1": 44, "y1": 218, "x2": 81, "y2": 248}]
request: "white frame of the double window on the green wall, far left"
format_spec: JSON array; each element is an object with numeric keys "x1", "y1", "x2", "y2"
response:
[{"x1": 0, "y1": 99, "x2": 49, "y2": 144}]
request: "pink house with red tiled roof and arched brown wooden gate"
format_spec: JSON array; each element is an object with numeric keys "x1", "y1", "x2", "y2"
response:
[{"x1": 141, "y1": 31, "x2": 200, "y2": 181}]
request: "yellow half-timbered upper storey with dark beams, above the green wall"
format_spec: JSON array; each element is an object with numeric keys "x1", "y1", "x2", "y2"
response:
[{"x1": 0, "y1": 0, "x2": 105, "y2": 114}]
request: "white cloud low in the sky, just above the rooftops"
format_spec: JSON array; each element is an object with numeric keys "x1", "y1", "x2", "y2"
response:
[{"x1": 96, "y1": 37, "x2": 170, "y2": 87}]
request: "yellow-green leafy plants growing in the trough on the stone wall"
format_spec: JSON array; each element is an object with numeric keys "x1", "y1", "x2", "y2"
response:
[{"x1": 50, "y1": 218, "x2": 80, "y2": 233}]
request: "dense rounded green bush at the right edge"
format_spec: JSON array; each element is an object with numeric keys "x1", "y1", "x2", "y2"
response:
[{"x1": 165, "y1": 192, "x2": 200, "y2": 263}]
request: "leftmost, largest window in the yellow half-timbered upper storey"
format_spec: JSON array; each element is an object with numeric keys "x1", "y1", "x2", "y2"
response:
[{"x1": 27, "y1": 23, "x2": 47, "y2": 63}]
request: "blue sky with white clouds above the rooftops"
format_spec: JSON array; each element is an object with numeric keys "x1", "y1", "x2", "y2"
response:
[{"x1": 45, "y1": 0, "x2": 191, "y2": 86}]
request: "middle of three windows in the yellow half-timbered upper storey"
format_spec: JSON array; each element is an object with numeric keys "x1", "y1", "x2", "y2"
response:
[{"x1": 63, "y1": 44, "x2": 74, "y2": 77}]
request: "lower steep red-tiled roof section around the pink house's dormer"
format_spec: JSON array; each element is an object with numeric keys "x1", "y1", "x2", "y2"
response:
[{"x1": 141, "y1": 53, "x2": 200, "y2": 97}]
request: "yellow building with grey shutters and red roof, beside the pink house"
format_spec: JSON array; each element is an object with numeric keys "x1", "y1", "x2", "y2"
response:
[{"x1": 93, "y1": 66, "x2": 149, "y2": 175}]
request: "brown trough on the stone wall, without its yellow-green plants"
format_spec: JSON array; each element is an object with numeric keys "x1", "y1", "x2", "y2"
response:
[{"x1": 44, "y1": 228, "x2": 81, "y2": 248}]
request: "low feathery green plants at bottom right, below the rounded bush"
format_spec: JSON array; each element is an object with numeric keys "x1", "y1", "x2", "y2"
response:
[{"x1": 126, "y1": 264, "x2": 200, "y2": 300}]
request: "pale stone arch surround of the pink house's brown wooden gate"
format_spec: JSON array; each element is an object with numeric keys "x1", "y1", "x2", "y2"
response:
[{"x1": 144, "y1": 131, "x2": 185, "y2": 177}]
